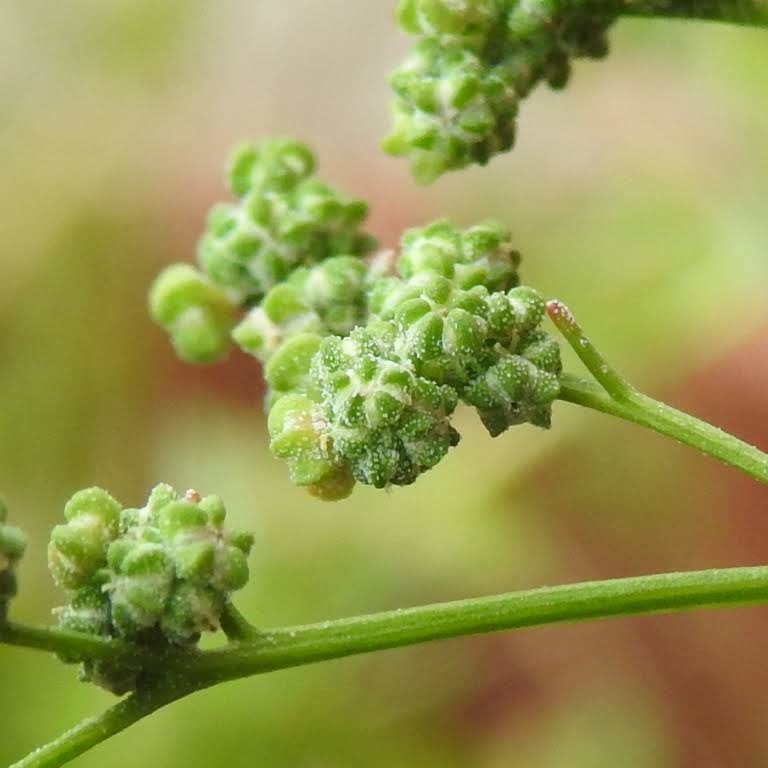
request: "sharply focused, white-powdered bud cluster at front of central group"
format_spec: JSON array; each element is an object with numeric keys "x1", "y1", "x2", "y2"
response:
[{"x1": 265, "y1": 221, "x2": 561, "y2": 498}]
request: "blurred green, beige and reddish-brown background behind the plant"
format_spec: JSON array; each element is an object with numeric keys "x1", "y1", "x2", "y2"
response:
[{"x1": 0, "y1": 0, "x2": 768, "y2": 768}]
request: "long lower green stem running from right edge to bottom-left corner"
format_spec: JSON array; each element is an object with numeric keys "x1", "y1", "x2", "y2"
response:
[{"x1": 12, "y1": 566, "x2": 768, "y2": 768}]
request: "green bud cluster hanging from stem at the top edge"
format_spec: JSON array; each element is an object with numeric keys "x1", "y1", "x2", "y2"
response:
[{"x1": 383, "y1": 0, "x2": 614, "y2": 183}]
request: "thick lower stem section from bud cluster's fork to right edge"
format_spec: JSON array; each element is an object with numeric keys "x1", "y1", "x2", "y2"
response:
[{"x1": 184, "y1": 566, "x2": 768, "y2": 686}]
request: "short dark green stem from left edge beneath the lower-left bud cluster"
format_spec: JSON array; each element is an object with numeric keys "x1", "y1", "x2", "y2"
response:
[{"x1": 0, "y1": 621, "x2": 131, "y2": 659}]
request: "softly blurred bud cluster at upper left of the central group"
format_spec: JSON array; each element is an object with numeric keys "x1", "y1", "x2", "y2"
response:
[{"x1": 149, "y1": 139, "x2": 376, "y2": 363}]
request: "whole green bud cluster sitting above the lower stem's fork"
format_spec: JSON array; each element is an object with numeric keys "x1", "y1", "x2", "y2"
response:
[{"x1": 48, "y1": 485, "x2": 253, "y2": 693}]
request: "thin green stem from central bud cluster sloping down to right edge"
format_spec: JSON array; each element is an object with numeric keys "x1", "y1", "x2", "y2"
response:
[{"x1": 559, "y1": 374, "x2": 768, "y2": 483}]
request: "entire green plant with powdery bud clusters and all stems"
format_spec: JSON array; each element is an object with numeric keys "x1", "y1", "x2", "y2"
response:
[{"x1": 0, "y1": 0, "x2": 768, "y2": 768}]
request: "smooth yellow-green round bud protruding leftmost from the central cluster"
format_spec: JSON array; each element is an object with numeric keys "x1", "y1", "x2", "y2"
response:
[{"x1": 149, "y1": 264, "x2": 234, "y2": 363}]
